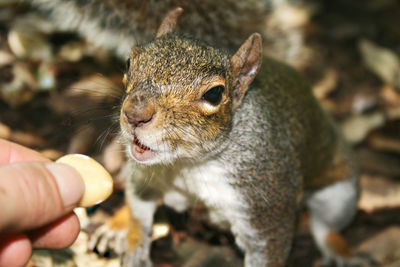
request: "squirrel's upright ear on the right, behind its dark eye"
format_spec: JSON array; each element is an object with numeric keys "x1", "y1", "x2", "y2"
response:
[{"x1": 230, "y1": 33, "x2": 262, "y2": 109}]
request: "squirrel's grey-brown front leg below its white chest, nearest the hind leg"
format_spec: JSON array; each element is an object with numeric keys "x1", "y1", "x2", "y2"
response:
[{"x1": 231, "y1": 183, "x2": 297, "y2": 267}]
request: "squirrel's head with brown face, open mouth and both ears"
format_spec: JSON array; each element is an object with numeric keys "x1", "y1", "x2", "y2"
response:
[{"x1": 120, "y1": 8, "x2": 262, "y2": 164}]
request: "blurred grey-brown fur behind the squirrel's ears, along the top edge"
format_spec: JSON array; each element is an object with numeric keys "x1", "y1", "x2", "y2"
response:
[{"x1": 29, "y1": 0, "x2": 307, "y2": 65}]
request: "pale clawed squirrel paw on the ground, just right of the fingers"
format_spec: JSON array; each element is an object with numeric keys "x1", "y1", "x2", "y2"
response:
[{"x1": 88, "y1": 224, "x2": 128, "y2": 256}]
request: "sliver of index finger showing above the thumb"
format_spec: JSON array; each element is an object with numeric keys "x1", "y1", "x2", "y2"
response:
[{"x1": 0, "y1": 139, "x2": 50, "y2": 165}]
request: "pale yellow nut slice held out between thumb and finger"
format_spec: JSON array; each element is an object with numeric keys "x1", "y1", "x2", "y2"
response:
[{"x1": 56, "y1": 154, "x2": 113, "y2": 207}]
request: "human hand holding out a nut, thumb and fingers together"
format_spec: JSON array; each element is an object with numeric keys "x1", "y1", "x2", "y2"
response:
[{"x1": 0, "y1": 139, "x2": 84, "y2": 266}]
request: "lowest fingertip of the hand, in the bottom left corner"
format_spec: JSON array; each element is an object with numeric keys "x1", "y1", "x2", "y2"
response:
[{"x1": 0, "y1": 234, "x2": 32, "y2": 267}]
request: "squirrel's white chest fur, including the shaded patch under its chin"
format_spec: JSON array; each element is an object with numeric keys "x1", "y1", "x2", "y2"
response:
[{"x1": 134, "y1": 161, "x2": 265, "y2": 252}]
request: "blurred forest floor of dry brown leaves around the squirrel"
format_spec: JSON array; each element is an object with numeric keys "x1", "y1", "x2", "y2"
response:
[{"x1": 0, "y1": 0, "x2": 400, "y2": 267}]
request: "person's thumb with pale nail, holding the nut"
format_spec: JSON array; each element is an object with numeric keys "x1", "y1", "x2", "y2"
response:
[{"x1": 0, "y1": 162, "x2": 84, "y2": 231}]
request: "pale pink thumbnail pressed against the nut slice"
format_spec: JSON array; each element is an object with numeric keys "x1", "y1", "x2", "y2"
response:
[{"x1": 46, "y1": 163, "x2": 84, "y2": 207}]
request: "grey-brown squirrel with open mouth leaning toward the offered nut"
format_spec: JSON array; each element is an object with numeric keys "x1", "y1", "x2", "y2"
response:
[{"x1": 114, "y1": 8, "x2": 359, "y2": 267}]
